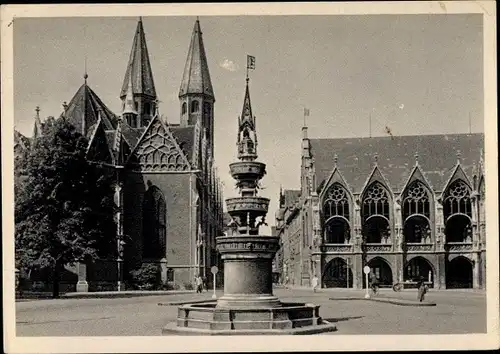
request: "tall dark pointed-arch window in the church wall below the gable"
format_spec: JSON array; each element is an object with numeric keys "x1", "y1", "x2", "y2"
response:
[{"x1": 143, "y1": 185, "x2": 167, "y2": 259}]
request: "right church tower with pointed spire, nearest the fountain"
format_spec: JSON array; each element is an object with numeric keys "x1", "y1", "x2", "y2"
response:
[{"x1": 179, "y1": 19, "x2": 215, "y2": 155}]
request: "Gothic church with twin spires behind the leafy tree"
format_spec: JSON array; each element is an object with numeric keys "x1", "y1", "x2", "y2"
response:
[{"x1": 15, "y1": 18, "x2": 223, "y2": 291}]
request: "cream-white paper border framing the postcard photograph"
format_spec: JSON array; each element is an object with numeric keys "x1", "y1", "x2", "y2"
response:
[{"x1": 1, "y1": 1, "x2": 500, "y2": 353}]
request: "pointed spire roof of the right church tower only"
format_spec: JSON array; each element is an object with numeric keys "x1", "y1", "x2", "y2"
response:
[{"x1": 179, "y1": 18, "x2": 215, "y2": 100}]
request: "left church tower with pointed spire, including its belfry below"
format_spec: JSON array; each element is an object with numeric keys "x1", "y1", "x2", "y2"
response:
[{"x1": 120, "y1": 18, "x2": 157, "y2": 128}]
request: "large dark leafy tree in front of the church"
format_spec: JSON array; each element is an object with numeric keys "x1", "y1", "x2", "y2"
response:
[{"x1": 15, "y1": 117, "x2": 116, "y2": 297}]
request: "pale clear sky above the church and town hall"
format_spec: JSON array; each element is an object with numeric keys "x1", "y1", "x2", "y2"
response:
[{"x1": 14, "y1": 14, "x2": 484, "y2": 234}]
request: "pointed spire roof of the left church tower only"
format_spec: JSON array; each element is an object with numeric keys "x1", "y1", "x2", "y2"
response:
[{"x1": 120, "y1": 17, "x2": 156, "y2": 99}]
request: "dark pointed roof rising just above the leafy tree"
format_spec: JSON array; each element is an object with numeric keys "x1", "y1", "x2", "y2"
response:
[{"x1": 62, "y1": 83, "x2": 117, "y2": 136}]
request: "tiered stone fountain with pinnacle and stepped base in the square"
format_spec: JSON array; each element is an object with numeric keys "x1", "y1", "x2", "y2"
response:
[{"x1": 163, "y1": 78, "x2": 336, "y2": 335}]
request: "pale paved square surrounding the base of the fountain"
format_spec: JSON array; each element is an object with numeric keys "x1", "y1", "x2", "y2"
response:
[{"x1": 16, "y1": 289, "x2": 486, "y2": 336}]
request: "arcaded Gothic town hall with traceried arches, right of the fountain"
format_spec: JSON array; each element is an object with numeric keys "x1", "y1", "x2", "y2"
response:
[{"x1": 276, "y1": 127, "x2": 486, "y2": 289}]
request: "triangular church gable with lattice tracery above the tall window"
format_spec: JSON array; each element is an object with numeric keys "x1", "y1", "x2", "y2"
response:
[{"x1": 128, "y1": 116, "x2": 191, "y2": 172}]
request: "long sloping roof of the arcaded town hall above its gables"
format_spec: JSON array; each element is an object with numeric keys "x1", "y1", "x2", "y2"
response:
[{"x1": 310, "y1": 133, "x2": 484, "y2": 193}]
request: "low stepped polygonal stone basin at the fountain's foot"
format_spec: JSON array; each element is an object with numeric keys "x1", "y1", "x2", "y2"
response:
[{"x1": 162, "y1": 301, "x2": 336, "y2": 335}]
